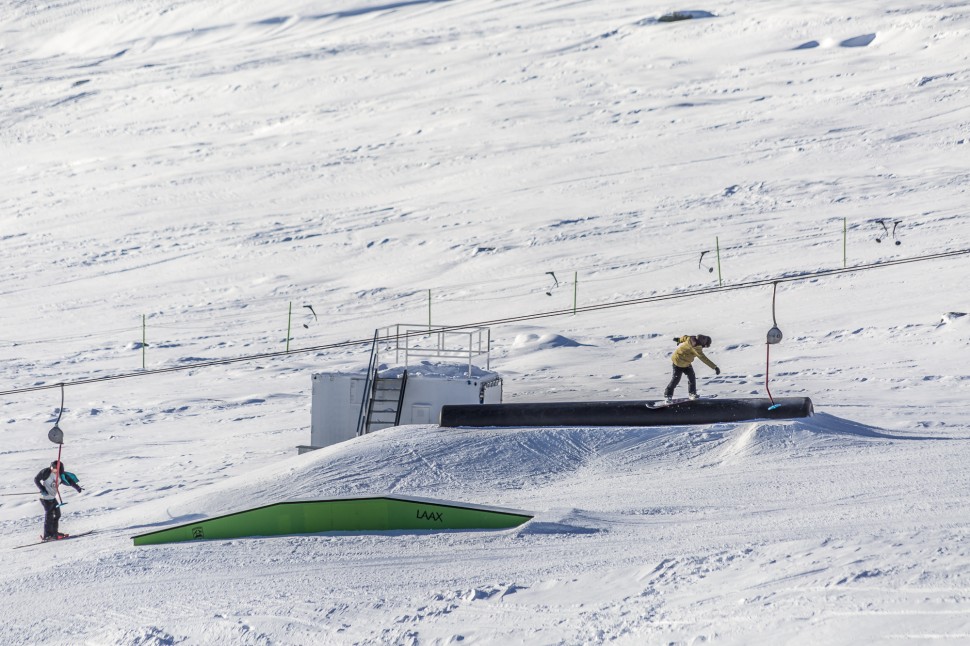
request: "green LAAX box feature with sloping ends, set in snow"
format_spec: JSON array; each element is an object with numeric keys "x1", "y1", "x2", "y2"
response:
[{"x1": 132, "y1": 496, "x2": 532, "y2": 546}]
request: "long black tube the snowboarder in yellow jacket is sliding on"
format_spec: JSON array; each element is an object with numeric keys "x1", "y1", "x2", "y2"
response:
[{"x1": 440, "y1": 397, "x2": 814, "y2": 427}]
